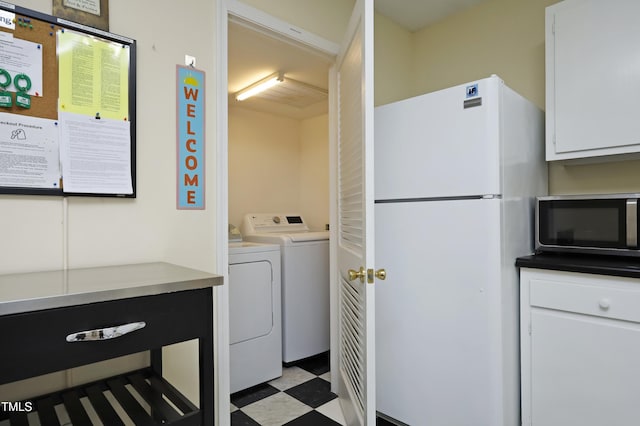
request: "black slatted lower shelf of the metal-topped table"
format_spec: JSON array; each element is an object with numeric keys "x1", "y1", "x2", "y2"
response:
[{"x1": 0, "y1": 368, "x2": 202, "y2": 426}]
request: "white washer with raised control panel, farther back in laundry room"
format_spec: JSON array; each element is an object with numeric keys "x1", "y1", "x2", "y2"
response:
[{"x1": 241, "y1": 214, "x2": 330, "y2": 364}]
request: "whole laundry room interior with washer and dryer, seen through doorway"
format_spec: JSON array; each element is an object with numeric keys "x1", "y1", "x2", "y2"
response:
[{"x1": 228, "y1": 17, "x2": 337, "y2": 411}]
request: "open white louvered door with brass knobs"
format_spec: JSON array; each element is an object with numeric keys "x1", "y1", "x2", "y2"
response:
[{"x1": 335, "y1": 0, "x2": 376, "y2": 425}]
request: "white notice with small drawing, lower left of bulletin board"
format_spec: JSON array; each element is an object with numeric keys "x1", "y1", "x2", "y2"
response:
[{"x1": 0, "y1": 113, "x2": 60, "y2": 189}]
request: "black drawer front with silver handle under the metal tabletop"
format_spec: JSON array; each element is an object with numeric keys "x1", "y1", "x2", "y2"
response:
[{"x1": 0, "y1": 289, "x2": 212, "y2": 384}]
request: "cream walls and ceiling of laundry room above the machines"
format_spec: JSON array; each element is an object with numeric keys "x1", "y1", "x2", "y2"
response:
[{"x1": 228, "y1": 20, "x2": 331, "y2": 230}]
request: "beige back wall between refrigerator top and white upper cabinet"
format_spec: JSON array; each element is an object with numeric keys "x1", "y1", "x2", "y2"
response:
[{"x1": 414, "y1": 0, "x2": 557, "y2": 109}]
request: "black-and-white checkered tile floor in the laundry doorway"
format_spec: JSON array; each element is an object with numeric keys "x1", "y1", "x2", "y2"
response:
[{"x1": 231, "y1": 354, "x2": 400, "y2": 426}]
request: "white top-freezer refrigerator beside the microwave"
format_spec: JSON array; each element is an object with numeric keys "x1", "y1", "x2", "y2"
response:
[{"x1": 375, "y1": 75, "x2": 547, "y2": 426}]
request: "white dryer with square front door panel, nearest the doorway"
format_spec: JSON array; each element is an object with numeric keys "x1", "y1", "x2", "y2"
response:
[{"x1": 229, "y1": 242, "x2": 282, "y2": 393}]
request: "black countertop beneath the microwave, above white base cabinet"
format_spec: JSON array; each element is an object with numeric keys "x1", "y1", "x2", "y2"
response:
[{"x1": 516, "y1": 253, "x2": 640, "y2": 278}]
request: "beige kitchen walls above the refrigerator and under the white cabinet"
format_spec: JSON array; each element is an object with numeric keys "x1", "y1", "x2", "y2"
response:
[{"x1": 375, "y1": 0, "x2": 640, "y2": 194}]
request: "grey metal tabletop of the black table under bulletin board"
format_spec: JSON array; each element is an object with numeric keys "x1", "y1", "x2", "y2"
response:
[{"x1": 0, "y1": 262, "x2": 223, "y2": 315}]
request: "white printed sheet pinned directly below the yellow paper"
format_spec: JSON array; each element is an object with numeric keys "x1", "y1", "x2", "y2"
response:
[{"x1": 59, "y1": 113, "x2": 133, "y2": 194}]
